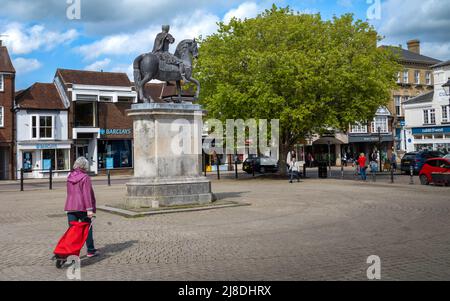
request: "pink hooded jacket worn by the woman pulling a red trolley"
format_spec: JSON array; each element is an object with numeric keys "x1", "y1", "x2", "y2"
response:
[{"x1": 64, "y1": 169, "x2": 97, "y2": 213}]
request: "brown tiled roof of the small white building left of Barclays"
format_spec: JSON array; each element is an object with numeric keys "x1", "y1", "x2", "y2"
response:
[{"x1": 16, "y1": 83, "x2": 66, "y2": 110}]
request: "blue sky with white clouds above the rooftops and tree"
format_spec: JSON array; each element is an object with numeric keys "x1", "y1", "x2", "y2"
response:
[{"x1": 0, "y1": 0, "x2": 450, "y2": 89}]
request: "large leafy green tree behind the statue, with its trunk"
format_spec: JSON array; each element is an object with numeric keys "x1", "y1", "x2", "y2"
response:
[{"x1": 196, "y1": 5, "x2": 399, "y2": 171}]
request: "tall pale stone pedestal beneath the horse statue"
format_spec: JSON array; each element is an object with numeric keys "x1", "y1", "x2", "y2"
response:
[{"x1": 125, "y1": 103, "x2": 213, "y2": 208}]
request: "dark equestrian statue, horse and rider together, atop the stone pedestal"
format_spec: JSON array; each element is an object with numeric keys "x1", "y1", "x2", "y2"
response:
[{"x1": 133, "y1": 25, "x2": 200, "y2": 103}]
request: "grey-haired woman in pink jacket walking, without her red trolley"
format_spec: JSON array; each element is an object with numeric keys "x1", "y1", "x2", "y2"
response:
[{"x1": 65, "y1": 157, "x2": 99, "y2": 258}]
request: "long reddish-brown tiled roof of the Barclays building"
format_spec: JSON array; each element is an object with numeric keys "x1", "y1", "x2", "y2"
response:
[{"x1": 56, "y1": 69, "x2": 131, "y2": 87}]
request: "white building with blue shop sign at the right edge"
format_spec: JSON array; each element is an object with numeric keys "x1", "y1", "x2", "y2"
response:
[{"x1": 404, "y1": 61, "x2": 450, "y2": 153}]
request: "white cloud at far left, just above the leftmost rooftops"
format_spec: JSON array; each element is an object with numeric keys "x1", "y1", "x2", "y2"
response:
[{"x1": 0, "y1": 23, "x2": 78, "y2": 55}]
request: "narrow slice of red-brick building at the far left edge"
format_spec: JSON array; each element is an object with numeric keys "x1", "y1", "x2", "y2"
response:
[{"x1": 0, "y1": 40, "x2": 16, "y2": 180}]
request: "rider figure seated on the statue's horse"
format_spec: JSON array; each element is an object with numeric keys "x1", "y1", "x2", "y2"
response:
[{"x1": 152, "y1": 25, "x2": 186, "y2": 80}]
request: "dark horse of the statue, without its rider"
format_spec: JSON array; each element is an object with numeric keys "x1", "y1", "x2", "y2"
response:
[{"x1": 133, "y1": 39, "x2": 200, "y2": 103}]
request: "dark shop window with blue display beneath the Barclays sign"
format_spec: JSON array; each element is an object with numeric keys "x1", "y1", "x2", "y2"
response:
[{"x1": 98, "y1": 140, "x2": 133, "y2": 169}]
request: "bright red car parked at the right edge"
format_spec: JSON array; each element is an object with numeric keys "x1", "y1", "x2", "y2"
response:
[{"x1": 419, "y1": 158, "x2": 450, "y2": 185}]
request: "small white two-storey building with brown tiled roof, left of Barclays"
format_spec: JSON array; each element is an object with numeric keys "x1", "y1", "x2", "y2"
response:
[{"x1": 16, "y1": 83, "x2": 72, "y2": 179}]
